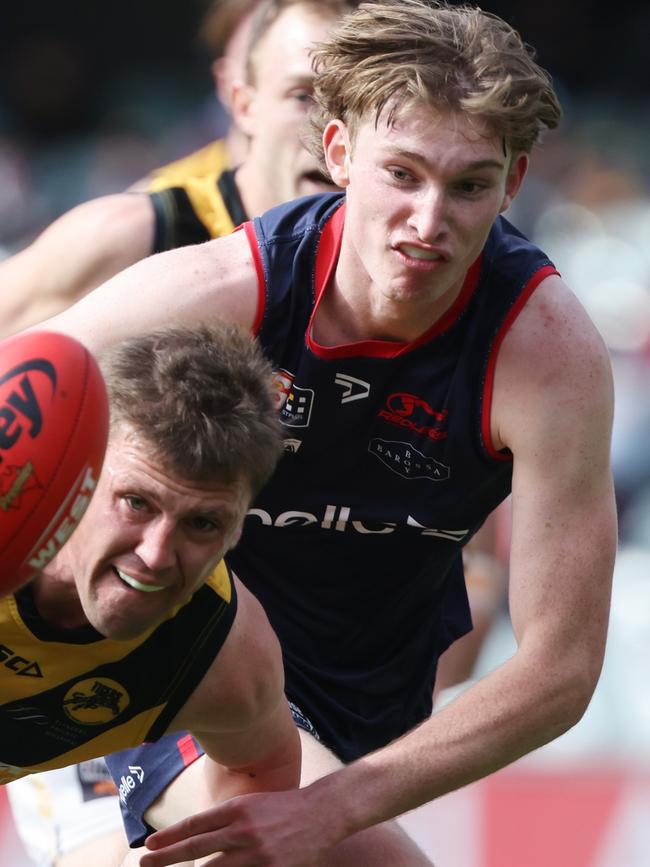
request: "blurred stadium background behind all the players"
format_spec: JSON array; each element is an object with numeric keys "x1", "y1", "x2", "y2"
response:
[{"x1": 0, "y1": 0, "x2": 650, "y2": 867}]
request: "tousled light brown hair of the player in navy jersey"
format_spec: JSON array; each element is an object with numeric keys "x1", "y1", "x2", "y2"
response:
[{"x1": 312, "y1": 0, "x2": 561, "y2": 156}]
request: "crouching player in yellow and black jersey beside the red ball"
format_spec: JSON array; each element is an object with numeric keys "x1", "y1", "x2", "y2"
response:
[{"x1": 0, "y1": 325, "x2": 300, "y2": 865}]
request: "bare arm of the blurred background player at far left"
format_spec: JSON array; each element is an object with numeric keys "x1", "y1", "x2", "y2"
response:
[{"x1": 0, "y1": 193, "x2": 154, "y2": 337}]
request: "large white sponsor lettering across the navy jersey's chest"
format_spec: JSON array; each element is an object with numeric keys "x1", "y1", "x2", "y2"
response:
[{"x1": 247, "y1": 504, "x2": 469, "y2": 542}]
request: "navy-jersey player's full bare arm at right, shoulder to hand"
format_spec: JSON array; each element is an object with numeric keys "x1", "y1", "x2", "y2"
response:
[{"x1": 142, "y1": 278, "x2": 616, "y2": 867}]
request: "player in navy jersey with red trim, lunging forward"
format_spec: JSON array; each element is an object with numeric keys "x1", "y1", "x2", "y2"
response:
[{"x1": 34, "y1": 0, "x2": 616, "y2": 867}]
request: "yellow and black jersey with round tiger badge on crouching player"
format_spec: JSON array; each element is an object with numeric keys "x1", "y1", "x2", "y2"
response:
[{"x1": 0, "y1": 561, "x2": 237, "y2": 783}]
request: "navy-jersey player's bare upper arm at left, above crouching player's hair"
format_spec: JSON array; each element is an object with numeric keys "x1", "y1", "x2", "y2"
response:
[{"x1": 29, "y1": 231, "x2": 258, "y2": 352}]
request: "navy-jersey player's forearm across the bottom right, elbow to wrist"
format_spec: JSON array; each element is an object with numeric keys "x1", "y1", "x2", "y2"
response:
[{"x1": 303, "y1": 652, "x2": 593, "y2": 839}]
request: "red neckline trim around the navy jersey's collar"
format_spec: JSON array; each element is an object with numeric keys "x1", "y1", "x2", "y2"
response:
[{"x1": 307, "y1": 205, "x2": 483, "y2": 358}]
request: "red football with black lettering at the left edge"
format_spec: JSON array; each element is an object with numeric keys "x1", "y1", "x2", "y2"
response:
[{"x1": 0, "y1": 331, "x2": 108, "y2": 595}]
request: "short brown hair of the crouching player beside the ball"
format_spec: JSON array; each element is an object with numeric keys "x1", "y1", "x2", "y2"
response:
[{"x1": 101, "y1": 323, "x2": 282, "y2": 494}]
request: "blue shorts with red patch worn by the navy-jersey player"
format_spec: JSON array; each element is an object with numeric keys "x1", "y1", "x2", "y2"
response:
[{"x1": 106, "y1": 702, "x2": 320, "y2": 848}]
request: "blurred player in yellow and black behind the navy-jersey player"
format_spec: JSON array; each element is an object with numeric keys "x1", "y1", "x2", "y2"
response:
[{"x1": 0, "y1": 0, "x2": 356, "y2": 337}]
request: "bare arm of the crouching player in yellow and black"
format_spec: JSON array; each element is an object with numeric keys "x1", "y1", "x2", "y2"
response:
[{"x1": 146, "y1": 582, "x2": 300, "y2": 828}]
